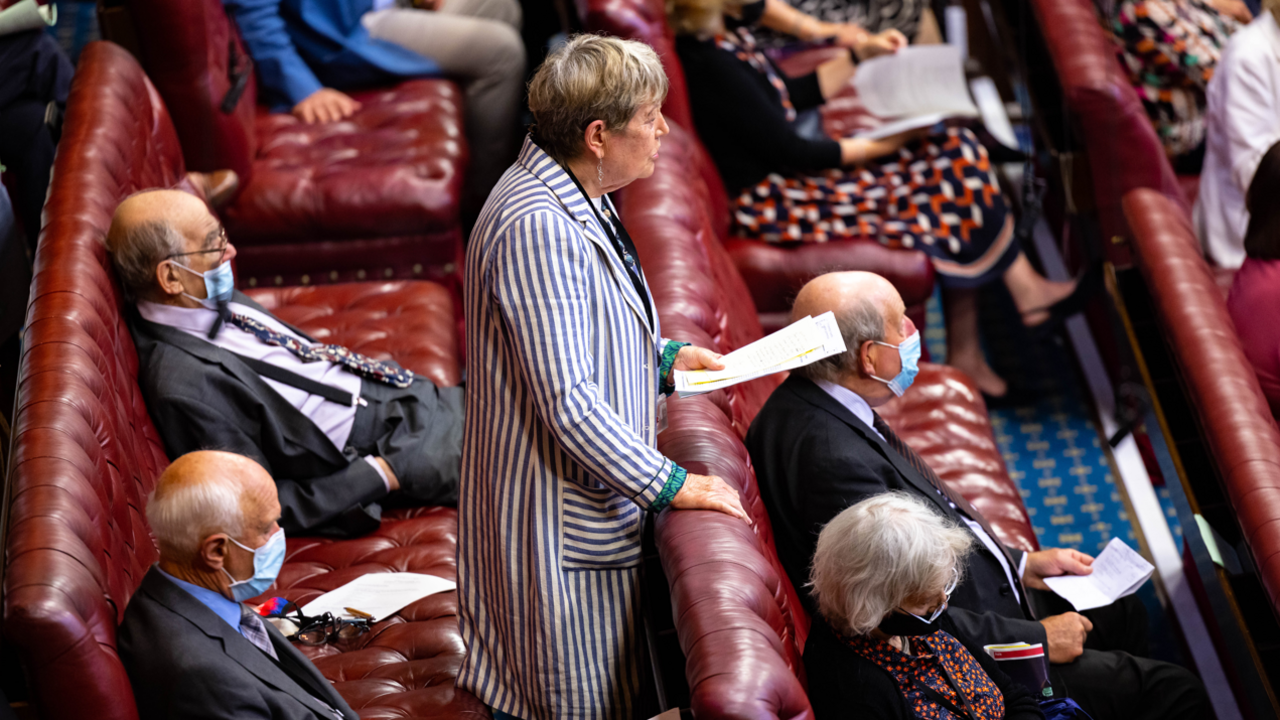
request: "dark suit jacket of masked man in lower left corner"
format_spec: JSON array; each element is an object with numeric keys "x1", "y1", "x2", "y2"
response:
[{"x1": 116, "y1": 566, "x2": 360, "y2": 720}]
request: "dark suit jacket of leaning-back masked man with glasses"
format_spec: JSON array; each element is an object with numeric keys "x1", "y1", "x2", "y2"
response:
[{"x1": 129, "y1": 292, "x2": 387, "y2": 536}]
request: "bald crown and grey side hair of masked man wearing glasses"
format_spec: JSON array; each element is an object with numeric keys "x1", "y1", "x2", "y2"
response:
[{"x1": 106, "y1": 190, "x2": 220, "y2": 300}]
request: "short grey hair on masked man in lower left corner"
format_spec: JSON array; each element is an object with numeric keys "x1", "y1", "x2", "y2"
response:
[{"x1": 147, "y1": 479, "x2": 244, "y2": 561}]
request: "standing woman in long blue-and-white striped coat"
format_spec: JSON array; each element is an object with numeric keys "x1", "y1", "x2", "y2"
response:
[{"x1": 458, "y1": 35, "x2": 746, "y2": 720}]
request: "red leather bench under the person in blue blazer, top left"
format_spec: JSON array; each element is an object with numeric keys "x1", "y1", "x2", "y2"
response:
[{"x1": 112, "y1": 0, "x2": 467, "y2": 290}]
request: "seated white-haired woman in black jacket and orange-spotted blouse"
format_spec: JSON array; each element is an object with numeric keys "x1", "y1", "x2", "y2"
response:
[{"x1": 804, "y1": 492, "x2": 1044, "y2": 720}]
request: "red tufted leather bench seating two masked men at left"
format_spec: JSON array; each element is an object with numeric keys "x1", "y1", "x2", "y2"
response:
[{"x1": 4, "y1": 42, "x2": 489, "y2": 720}]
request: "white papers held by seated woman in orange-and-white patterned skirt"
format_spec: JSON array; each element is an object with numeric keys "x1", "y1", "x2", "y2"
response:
[{"x1": 854, "y1": 45, "x2": 978, "y2": 140}]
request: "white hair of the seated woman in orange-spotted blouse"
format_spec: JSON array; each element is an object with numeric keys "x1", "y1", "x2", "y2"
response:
[{"x1": 809, "y1": 492, "x2": 973, "y2": 635}]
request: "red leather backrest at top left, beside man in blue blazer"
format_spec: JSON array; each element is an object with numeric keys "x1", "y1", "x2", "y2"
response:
[{"x1": 125, "y1": 0, "x2": 257, "y2": 187}]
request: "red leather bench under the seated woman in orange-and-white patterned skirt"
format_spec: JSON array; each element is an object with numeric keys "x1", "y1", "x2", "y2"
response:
[{"x1": 577, "y1": 0, "x2": 933, "y2": 331}]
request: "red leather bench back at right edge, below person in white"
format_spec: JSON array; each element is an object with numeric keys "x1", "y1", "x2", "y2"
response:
[{"x1": 1124, "y1": 190, "x2": 1280, "y2": 615}]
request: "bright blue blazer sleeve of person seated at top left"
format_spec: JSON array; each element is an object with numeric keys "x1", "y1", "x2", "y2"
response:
[{"x1": 223, "y1": 0, "x2": 324, "y2": 106}]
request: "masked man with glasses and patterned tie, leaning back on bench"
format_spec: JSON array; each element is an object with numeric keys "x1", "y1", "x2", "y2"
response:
[{"x1": 106, "y1": 190, "x2": 463, "y2": 537}]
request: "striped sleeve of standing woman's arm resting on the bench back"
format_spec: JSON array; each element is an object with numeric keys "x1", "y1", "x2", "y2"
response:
[{"x1": 492, "y1": 213, "x2": 685, "y2": 511}]
